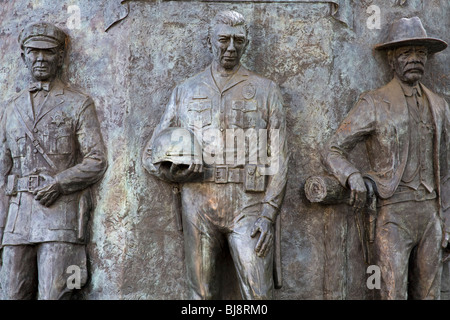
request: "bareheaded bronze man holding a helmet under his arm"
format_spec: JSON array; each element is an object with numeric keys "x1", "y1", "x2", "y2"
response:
[{"x1": 143, "y1": 11, "x2": 288, "y2": 299}]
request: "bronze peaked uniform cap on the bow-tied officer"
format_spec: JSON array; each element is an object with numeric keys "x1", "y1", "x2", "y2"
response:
[{"x1": 18, "y1": 22, "x2": 67, "y2": 49}]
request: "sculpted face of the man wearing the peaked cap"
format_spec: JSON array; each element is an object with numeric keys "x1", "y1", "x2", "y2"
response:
[{"x1": 22, "y1": 47, "x2": 63, "y2": 81}]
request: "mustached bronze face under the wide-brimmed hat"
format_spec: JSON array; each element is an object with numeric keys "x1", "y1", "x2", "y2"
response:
[{"x1": 391, "y1": 46, "x2": 428, "y2": 84}]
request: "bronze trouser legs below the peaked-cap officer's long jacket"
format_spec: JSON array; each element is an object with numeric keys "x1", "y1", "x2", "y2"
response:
[{"x1": 0, "y1": 242, "x2": 87, "y2": 300}]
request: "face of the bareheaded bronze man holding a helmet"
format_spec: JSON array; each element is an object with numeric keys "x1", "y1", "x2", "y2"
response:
[{"x1": 208, "y1": 24, "x2": 248, "y2": 69}]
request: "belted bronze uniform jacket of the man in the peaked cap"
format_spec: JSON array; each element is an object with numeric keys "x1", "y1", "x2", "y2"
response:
[{"x1": 0, "y1": 80, "x2": 107, "y2": 245}]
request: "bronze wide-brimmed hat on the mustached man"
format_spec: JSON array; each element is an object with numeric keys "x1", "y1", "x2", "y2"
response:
[{"x1": 374, "y1": 17, "x2": 447, "y2": 53}]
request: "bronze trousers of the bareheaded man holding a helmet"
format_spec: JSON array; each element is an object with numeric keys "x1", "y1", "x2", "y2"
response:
[{"x1": 181, "y1": 183, "x2": 274, "y2": 300}]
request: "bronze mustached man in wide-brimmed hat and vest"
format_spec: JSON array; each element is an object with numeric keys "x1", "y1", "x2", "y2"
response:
[{"x1": 323, "y1": 17, "x2": 450, "y2": 299}]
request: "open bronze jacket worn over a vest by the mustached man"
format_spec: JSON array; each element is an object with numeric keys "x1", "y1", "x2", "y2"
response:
[{"x1": 323, "y1": 78, "x2": 450, "y2": 230}]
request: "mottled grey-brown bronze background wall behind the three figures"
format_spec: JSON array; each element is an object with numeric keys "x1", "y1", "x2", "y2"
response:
[{"x1": 0, "y1": 0, "x2": 450, "y2": 299}]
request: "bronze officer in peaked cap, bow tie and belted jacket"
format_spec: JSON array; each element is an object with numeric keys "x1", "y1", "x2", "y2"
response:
[{"x1": 0, "y1": 22, "x2": 107, "y2": 299}]
